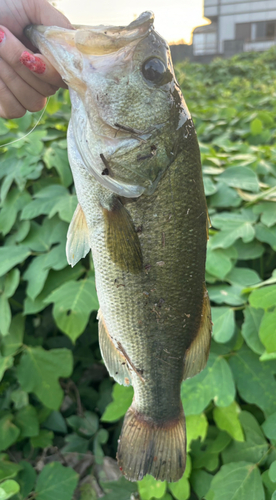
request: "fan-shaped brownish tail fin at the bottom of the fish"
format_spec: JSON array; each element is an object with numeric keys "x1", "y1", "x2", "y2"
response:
[{"x1": 117, "y1": 406, "x2": 186, "y2": 482}]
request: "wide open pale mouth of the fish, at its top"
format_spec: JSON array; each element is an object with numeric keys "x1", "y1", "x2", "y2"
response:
[{"x1": 24, "y1": 11, "x2": 154, "y2": 56}]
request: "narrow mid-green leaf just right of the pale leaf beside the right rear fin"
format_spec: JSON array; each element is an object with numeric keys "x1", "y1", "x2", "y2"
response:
[{"x1": 241, "y1": 306, "x2": 264, "y2": 354}]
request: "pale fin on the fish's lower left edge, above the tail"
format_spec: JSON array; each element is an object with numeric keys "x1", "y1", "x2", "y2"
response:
[{"x1": 98, "y1": 310, "x2": 131, "y2": 385}]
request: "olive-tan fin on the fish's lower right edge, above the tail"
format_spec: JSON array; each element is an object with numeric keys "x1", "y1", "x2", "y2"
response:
[{"x1": 183, "y1": 285, "x2": 212, "y2": 380}]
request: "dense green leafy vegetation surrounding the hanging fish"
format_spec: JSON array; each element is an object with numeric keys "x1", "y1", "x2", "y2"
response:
[{"x1": 0, "y1": 50, "x2": 276, "y2": 500}]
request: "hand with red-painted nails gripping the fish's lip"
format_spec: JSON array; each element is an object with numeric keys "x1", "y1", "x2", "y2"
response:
[{"x1": 0, "y1": 0, "x2": 72, "y2": 118}]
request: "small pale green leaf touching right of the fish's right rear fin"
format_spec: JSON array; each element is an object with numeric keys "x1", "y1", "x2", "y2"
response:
[{"x1": 212, "y1": 307, "x2": 235, "y2": 343}]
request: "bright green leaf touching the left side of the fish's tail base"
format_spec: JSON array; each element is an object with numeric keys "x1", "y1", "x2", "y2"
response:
[{"x1": 101, "y1": 384, "x2": 133, "y2": 422}]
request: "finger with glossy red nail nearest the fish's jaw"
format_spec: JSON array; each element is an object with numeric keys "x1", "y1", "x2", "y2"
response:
[{"x1": 0, "y1": 26, "x2": 64, "y2": 90}]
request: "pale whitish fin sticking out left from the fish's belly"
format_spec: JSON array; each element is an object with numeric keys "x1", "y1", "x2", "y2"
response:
[{"x1": 66, "y1": 204, "x2": 90, "y2": 267}]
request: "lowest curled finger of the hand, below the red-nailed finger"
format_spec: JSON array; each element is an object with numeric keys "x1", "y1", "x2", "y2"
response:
[{"x1": 0, "y1": 59, "x2": 47, "y2": 113}]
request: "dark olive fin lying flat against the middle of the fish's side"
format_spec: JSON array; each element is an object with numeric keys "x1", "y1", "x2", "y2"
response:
[{"x1": 103, "y1": 198, "x2": 143, "y2": 274}]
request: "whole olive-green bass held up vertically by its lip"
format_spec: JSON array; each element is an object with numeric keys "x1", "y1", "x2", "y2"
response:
[{"x1": 26, "y1": 12, "x2": 212, "y2": 482}]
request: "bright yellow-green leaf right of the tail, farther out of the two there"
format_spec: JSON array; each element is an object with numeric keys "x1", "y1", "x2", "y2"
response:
[{"x1": 213, "y1": 401, "x2": 244, "y2": 441}]
